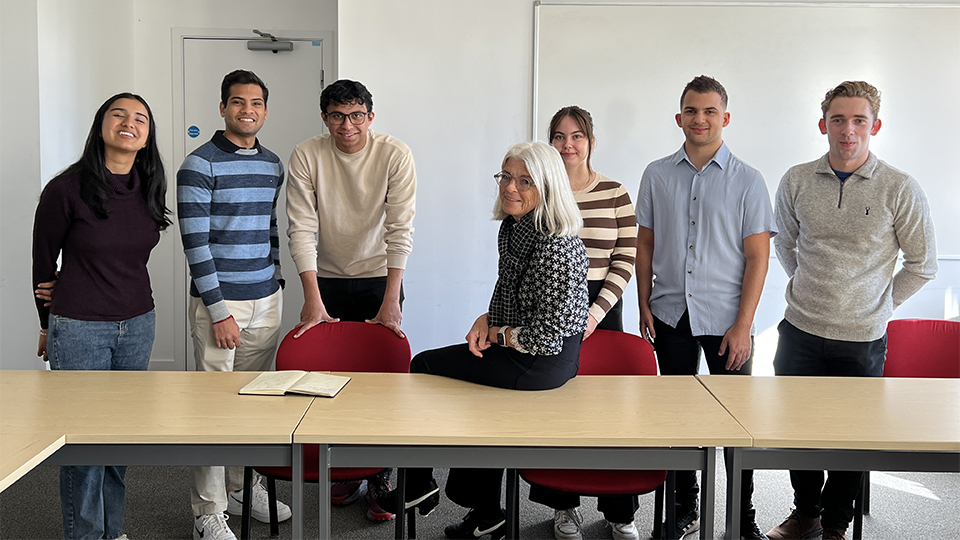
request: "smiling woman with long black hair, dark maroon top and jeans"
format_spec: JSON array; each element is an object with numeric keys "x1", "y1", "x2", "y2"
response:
[{"x1": 33, "y1": 93, "x2": 170, "y2": 540}]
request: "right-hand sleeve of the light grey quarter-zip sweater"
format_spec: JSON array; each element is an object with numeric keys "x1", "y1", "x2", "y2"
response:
[{"x1": 893, "y1": 177, "x2": 937, "y2": 308}]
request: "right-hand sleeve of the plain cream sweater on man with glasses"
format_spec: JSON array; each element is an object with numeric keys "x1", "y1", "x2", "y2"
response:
[{"x1": 383, "y1": 150, "x2": 417, "y2": 270}]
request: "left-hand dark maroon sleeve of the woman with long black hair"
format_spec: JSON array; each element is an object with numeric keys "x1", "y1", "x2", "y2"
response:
[{"x1": 31, "y1": 179, "x2": 73, "y2": 329}]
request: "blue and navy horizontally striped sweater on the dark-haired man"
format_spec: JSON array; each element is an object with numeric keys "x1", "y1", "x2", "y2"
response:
[{"x1": 177, "y1": 131, "x2": 283, "y2": 322}]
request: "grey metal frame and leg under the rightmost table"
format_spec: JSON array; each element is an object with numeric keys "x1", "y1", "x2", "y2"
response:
[{"x1": 726, "y1": 447, "x2": 960, "y2": 538}]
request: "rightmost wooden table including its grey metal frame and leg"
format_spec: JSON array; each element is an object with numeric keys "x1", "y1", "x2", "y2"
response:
[{"x1": 698, "y1": 375, "x2": 960, "y2": 538}]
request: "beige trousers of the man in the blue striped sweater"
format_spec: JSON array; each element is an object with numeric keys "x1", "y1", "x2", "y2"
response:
[{"x1": 187, "y1": 290, "x2": 283, "y2": 516}]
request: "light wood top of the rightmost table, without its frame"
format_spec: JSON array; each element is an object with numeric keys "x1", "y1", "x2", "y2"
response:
[{"x1": 698, "y1": 375, "x2": 960, "y2": 452}]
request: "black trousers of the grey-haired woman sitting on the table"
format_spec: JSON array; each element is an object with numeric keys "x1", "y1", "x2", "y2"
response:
[{"x1": 407, "y1": 334, "x2": 583, "y2": 517}]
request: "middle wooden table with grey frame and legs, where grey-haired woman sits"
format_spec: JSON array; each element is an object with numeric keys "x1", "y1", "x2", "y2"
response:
[{"x1": 294, "y1": 373, "x2": 751, "y2": 538}]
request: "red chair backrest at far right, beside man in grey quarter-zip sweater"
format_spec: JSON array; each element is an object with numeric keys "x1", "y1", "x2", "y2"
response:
[{"x1": 883, "y1": 319, "x2": 960, "y2": 378}]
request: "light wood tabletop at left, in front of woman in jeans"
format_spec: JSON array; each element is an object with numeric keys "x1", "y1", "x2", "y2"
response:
[{"x1": 0, "y1": 370, "x2": 313, "y2": 444}]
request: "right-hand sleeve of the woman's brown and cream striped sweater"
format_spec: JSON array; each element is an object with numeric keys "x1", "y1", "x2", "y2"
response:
[{"x1": 590, "y1": 186, "x2": 637, "y2": 322}]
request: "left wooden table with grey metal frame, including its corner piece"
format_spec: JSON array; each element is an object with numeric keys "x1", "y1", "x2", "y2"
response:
[{"x1": 0, "y1": 370, "x2": 313, "y2": 537}]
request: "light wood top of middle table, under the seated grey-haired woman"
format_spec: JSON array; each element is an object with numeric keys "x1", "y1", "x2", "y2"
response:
[{"x1": 294, "y1": 373, "x2": 751, "y2": 447}]
